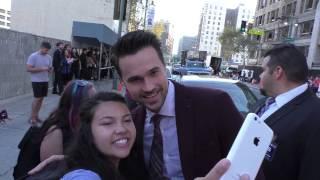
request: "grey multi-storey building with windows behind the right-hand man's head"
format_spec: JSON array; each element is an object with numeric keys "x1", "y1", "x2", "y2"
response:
[{"x1": 254, "y1": 0, "x2": 320, "y2": 69}]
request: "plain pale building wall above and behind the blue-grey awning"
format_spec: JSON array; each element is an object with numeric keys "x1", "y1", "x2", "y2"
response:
[{"x1": 11, "y1": 0, "x2": 119, "y2": 41}]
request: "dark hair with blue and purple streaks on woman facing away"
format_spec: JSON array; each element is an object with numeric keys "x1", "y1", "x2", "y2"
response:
[{"x1": 39, "y1": 80, "x2": 93, "y2": 143}]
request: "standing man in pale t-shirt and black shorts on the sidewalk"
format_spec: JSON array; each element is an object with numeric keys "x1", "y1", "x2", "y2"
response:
[{"x1": 27, "y1": 42, "x2": 52, "y2": 126}]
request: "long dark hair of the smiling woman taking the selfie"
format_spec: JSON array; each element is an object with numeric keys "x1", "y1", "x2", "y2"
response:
[{"x1": 66, "y1": 92, "x2": 126, "y2": 180}]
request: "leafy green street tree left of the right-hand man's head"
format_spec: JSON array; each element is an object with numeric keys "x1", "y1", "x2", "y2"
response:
[{"x1": 219, "y1": 28, "x2": 257, "y2": 65}]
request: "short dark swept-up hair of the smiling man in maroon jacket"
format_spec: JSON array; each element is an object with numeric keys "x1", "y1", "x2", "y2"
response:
[{"x1": 112, "y1": 30, "x2": 165, "y2": 77}]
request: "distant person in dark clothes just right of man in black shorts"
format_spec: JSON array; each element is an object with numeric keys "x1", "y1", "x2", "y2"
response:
[{"x1": 52, "y1": 42, "x2": 64, "y2": 94}]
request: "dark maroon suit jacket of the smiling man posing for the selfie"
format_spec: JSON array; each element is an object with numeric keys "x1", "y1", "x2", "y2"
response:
[{"x1": 120, "y1": 83, "x2": 264, "y2": 180}]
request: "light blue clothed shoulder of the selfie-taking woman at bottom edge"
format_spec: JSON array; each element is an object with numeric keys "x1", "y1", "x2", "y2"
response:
[{"x1": 61, "y1": 169, "x2": 101, "y2": 180}]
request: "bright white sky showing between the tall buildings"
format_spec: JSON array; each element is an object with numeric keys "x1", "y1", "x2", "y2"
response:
[{"x1": 154, "y1": 0, "x2": 257, "y2": 54}]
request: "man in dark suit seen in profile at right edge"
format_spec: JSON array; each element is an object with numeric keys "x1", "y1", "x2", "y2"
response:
[{"x1": 257, "y1": 44, "x2": 320, "y2": 180}]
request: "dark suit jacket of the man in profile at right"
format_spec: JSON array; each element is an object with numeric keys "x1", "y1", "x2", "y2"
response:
[{"x1": 263, "y1": 89, "x2": 320, "y2": 180}]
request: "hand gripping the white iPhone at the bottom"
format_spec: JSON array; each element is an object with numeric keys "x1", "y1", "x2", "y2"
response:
[{"x1": 195, "y1": 159, "x2": 250, "y2": 180}]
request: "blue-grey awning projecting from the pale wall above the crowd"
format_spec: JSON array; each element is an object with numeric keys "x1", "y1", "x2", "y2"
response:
[{"x1": 72, "y1": 21, "x2": 118, "y2": 45}]
